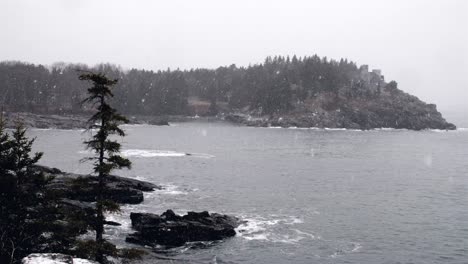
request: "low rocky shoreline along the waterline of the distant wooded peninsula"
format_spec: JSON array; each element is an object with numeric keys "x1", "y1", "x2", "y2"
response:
[{"x1": 6, "y1": 104, "x2": 456, "y2": 130}]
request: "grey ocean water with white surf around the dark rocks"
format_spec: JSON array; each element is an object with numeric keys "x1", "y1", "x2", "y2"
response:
[{"x1": 30, "y1": 122, "x2": 468, "y2": 264}]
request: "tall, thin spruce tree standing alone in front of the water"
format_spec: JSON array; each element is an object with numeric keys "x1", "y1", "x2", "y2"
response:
[{"x1": 79, "y1": 72, "x2": 131, "y2": 263}]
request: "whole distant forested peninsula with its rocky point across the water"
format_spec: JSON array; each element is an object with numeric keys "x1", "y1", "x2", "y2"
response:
[{"x1": 0, "y1": 55, "x2": 456, "y2": 130}]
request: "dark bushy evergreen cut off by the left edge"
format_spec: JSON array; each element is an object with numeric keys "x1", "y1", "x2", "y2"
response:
[{"x1": 0, "y1": 120, "x2": 50, "y2": 263}]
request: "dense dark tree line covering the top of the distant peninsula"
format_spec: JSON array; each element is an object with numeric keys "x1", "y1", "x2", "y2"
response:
[{"x1": 0, "y1": 55, "x2": 382, "y2": 115}]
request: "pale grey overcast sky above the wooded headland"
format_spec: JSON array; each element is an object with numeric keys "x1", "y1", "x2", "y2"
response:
[{"x1": 0, "y1": 0, "x2": 468, "y2": 115}]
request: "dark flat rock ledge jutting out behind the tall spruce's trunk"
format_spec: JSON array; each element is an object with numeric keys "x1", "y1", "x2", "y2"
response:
[{"x1": 33, "y1": 166, "x2": 161, "y2": 204}]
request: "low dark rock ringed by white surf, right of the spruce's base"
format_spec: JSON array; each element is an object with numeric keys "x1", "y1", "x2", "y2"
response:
[{"x1": 126, "y1": 210, "x2": 240, "y2": 247}]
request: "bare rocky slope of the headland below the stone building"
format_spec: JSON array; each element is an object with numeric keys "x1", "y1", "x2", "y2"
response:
[{"x1": 226, "y1": 85, "x2": 456, "y2": 130}]
